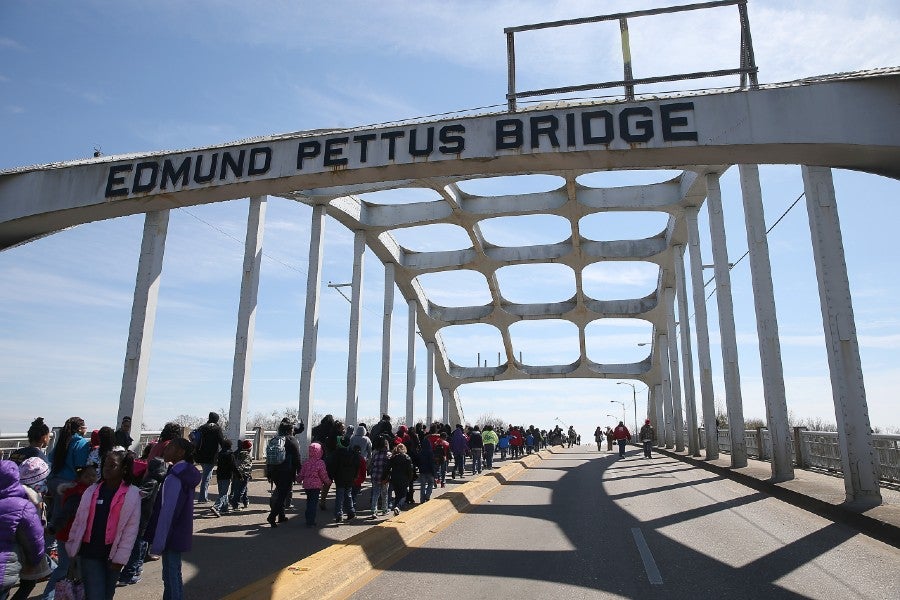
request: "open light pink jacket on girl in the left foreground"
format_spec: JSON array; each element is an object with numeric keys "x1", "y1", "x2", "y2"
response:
[{"x1": 66, "y1": 483, "x2": 141, "y2": 565}]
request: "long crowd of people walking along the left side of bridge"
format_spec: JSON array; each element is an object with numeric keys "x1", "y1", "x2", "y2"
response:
[{"x1": 0, "y1": 412, "x2": 604, "y2": 600}]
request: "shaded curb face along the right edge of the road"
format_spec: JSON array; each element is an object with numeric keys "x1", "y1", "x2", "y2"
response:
[{"x1": 653, "y1": 446, "x2": 900, "y2": 548}]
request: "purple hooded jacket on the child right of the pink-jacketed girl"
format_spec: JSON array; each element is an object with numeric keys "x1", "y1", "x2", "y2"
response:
[{"x1": 144, "y1": 460, "x2": 201, "y2": 554}]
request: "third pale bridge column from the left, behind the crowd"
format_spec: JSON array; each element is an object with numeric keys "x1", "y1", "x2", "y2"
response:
[{"x1": 299, "y1": 204, "x2": 326, "y2": 456}]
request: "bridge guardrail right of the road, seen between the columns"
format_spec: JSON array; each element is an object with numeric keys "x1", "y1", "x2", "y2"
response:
[{"x1": 700, "y1": 427, "x2": 900, "y2": 483}]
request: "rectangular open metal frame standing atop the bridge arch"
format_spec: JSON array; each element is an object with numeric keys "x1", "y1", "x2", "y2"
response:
[{"x1": 503, "y1": 0, "x2": 759, "y2": 112}]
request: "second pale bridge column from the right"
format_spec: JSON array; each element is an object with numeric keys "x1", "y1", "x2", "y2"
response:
[{"x1": 738, "y1": 165, "x2": 794, "y2": 481}]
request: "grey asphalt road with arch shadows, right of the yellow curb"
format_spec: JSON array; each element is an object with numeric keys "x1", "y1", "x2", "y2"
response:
[{"x1": 352, "y1": 446, "x2": 900, "y2": 600}]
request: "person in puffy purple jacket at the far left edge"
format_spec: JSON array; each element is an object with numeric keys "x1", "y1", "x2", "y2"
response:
[{"x1": 0, "y1": 460, "x2": 44, "y2": 600}]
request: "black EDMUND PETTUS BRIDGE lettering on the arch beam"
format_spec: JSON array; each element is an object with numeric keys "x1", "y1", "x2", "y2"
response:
[{"x1": 104, "y1": 102, "x2": 697, "y2": 198}]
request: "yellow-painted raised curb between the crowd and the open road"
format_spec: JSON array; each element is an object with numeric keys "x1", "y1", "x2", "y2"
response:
[{"x1": 224, "y1": 453, "x2": 543, "y2": 600}]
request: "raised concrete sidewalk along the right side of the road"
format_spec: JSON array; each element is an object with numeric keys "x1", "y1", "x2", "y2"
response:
[{"x1": 653, "y1": 447, "x2": 900, "y2": 548}]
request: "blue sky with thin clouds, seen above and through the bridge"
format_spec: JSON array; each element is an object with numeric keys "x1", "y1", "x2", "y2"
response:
[{"x1": 0, "y1": 0, "x2": 900, "y2": 434}]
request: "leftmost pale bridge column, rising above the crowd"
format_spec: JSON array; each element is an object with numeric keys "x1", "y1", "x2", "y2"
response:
[{"x1": 116, "y1": 210, "x2": 169, "y2": 448}]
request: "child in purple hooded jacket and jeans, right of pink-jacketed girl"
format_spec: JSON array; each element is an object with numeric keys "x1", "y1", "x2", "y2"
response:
[{"x1": 144, "y1": 438, "x2": 201, "y2": 600}]
